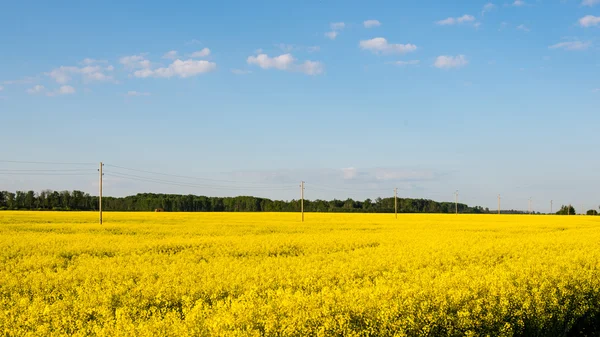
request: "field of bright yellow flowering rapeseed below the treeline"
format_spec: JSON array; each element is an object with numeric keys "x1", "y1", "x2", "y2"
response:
[{"x1": 0, "y1": 211, "x2": 600, "y2": 336}]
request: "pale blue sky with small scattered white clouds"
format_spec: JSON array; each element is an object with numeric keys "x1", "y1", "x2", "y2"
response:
[{"x1": 0, "y1": 0, "x2": 600, "y2": 211}]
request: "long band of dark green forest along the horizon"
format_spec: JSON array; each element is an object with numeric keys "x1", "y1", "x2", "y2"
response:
[{"x1": 0, "y1": 190, "x2": 536, "y2": 213}]
